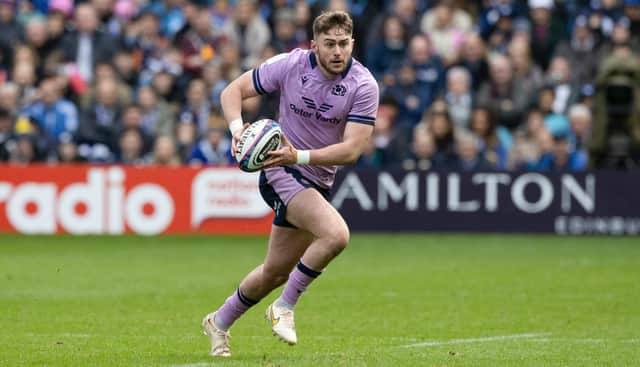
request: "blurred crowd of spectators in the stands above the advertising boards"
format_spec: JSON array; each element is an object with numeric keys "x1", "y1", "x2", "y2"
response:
[{"x1": 0, "y1": 0, "x2": 640, "y2": 171}]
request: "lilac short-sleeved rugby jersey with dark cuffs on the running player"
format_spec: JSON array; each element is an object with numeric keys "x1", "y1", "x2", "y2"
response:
[{"x1": 253, "y1": 49, "x2": 379, "y2": 188}]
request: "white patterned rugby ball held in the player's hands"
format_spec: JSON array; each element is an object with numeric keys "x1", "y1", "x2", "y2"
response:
[{"x1": 236, "y1": 119, "x2": 282, "y2": 172}]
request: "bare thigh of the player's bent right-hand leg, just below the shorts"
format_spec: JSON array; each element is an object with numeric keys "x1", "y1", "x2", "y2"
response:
[{"x1": 287, "y1": 189, "x2": 348, "y2": 237}]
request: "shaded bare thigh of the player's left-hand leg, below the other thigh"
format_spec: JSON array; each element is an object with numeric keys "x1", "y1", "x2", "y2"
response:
[{"x1": 264, "y1": 225, "x2": 313, "y2": 273}]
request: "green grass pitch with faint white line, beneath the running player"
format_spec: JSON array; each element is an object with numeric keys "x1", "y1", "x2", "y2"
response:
[{"x1": 0, "y1": 234, "x2": 640, "y2": 367}]
